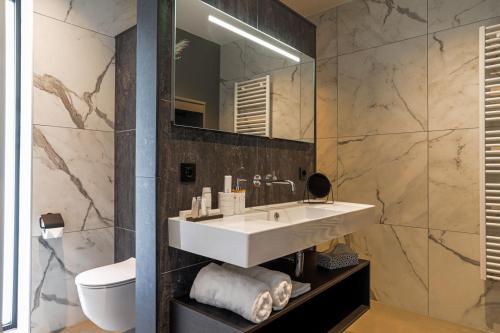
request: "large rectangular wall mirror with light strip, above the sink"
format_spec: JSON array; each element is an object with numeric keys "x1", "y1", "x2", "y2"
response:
[{"x1": 174, "y1": 0, "x2": 315, "y2": 142}]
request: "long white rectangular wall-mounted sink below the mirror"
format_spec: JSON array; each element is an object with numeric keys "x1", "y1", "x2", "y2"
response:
[{"x1": 168, "y1": 202, "x2": 375, "y2": 267}]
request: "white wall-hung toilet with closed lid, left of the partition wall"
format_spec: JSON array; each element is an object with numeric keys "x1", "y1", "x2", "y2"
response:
[{"x1": 75, "y1": 258, "x2": 135, "y2": 332}]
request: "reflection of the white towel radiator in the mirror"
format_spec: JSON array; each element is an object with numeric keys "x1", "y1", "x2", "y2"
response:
[{"x1": 234, "y1": 75, "x2": 271, "y2": 137}]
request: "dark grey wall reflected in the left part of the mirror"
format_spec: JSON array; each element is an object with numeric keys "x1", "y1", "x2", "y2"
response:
[{"x1": 175, "y1": 29, "x2": 220, "y2": 129}]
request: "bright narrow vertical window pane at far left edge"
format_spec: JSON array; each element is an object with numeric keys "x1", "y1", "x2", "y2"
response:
[{"x1": 2, "y1": 0, "x2": 17, "y2": 327}]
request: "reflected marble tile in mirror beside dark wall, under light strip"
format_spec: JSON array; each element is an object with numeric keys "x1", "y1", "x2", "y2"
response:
[{"x1": 220, "y1": 39, "x2": 247, "y2": 80}]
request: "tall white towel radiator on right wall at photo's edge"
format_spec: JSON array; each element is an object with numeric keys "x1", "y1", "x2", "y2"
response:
[{"x1": 479, "y1": 24, "x2": 500, "y2": 281}]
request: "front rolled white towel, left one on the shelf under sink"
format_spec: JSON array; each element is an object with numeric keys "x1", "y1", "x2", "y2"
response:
[{"x1": 189, "y1": 263, "x2": 273, "y2": 323}]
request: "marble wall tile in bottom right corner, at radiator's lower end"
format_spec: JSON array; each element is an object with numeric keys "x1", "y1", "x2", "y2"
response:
[{"x1": 429, "y1": 230, "x2": 500, "y2": 330}]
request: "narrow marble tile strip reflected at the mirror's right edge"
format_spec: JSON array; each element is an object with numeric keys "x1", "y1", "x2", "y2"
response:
[{"x1": 300, "y1": 62, "x2": 316, "y2": 143}]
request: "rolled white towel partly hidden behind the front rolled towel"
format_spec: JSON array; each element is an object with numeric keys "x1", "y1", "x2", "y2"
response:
[{"x1": 222, "y1": 264, "x2": 292, "y2": 311}]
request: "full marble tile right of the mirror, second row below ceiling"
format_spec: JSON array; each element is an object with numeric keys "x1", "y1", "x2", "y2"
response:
[{"x1": 338, "y1": 36, "x2": 427, "y2": 136}]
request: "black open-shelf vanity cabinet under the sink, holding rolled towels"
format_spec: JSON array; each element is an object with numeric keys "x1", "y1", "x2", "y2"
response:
[{"x1": 170, "y1": 259, "x2": 370, "y2": 333}]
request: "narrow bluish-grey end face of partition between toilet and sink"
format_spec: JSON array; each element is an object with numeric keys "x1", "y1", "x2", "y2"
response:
[{"x1": 135, "y1": 0, "x2": 158, "y2": 333}]
